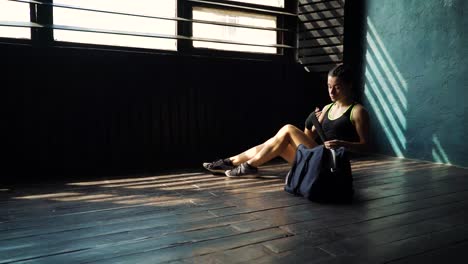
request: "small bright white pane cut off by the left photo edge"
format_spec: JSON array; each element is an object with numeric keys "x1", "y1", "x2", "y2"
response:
[{"x1": 0, "y1": 1, "x2": 31, "y2": 39}]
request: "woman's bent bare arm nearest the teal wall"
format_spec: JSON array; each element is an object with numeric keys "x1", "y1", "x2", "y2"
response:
[{"x1": 324, "y1": 105, "x2": 369, "y2": 152}]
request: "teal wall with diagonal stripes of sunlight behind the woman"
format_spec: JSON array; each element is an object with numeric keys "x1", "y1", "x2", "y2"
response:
[{"x1": 363, "y1": 0, "x2": 468, "y2": 167}]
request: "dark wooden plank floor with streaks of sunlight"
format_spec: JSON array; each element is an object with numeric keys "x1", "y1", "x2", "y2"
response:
[{"x1": 0, "y1": 157, "x2": 468, "y2": 263}]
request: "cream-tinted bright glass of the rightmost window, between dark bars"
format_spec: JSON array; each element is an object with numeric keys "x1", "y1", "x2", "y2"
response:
[{"x1": 193, "y1": 7, "x2": 277, "y2": 53}]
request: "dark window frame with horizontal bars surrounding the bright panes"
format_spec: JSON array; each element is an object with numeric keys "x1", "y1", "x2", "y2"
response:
[{"x1": 0, "y1": 0, "x2": 297, "y2": 60}]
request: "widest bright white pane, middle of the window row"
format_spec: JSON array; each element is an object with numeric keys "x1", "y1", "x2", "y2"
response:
[{"x1": 54, "y1": 0, "x2": 177, "y2": 50}]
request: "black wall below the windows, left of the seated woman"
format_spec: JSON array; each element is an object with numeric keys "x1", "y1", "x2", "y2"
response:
[{"x1": 0, "y1": 44, "x2": 326, "y2": 183}]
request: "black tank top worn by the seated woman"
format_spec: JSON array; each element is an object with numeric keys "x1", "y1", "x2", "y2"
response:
[{"x1": 322, "y1": 103, "x2": 359, "y2": 142}]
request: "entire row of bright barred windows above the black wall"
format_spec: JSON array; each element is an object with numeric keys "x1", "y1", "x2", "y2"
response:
[{"x1": 0, "y1": 0, "x2": 297, "y2": 58}]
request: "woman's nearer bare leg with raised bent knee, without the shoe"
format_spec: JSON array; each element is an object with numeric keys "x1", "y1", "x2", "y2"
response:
[{"x1": 247, "y1": 125, "x2": 317, "y2": 167}]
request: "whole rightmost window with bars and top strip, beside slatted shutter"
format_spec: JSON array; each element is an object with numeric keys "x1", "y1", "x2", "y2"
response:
[{"x1": 188, "y1": 0, "x2": 297, "y2": 54}]
